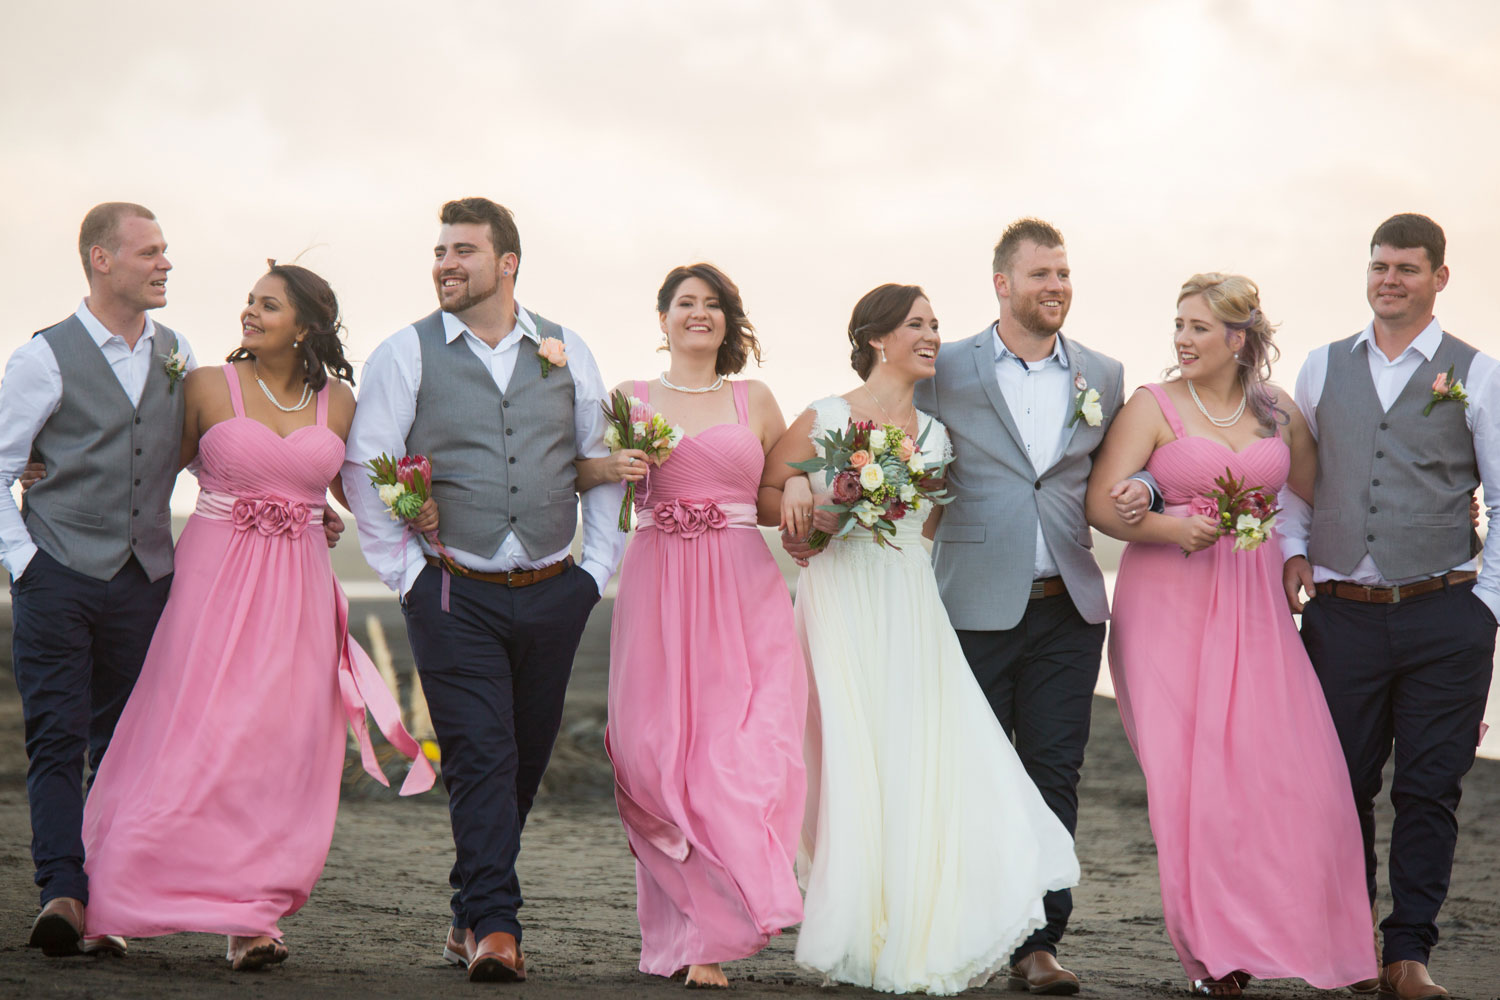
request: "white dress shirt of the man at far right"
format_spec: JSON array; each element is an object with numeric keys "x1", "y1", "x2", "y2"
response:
[{"x1": 1277, "y1": 318, "x2": 1500, "y2": 618}]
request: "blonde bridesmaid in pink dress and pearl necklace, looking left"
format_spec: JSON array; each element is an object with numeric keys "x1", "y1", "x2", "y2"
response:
[{"x1": 1088, "y1": 274, "x2": 1376, "y2": 997}]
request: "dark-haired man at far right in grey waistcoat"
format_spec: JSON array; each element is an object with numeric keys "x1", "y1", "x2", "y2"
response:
[{"x1": 1283, "y1": 214, "x2": 1500, "y2": 1000}]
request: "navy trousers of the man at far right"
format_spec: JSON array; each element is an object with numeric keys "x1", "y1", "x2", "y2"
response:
[{"x1": 1302, "y1": 583, "x2": 1496, "y2": 964}]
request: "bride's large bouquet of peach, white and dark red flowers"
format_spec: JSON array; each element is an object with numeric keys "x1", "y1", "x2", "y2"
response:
[{"x1": 791, "y1": 420, "x2": 953, "y2": 549}]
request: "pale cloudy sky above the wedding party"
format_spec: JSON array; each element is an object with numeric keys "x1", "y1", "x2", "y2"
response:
[{"x1": 0, "y1": 0, "x2": 1500, "y2": 515}]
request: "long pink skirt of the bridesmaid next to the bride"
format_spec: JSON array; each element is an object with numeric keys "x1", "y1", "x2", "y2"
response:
[{"x1": 608, "y1": 521, "x2": 807, "y2": 976}]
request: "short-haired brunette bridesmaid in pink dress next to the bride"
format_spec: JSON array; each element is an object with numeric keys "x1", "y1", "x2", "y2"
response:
[{"x1": 579, "y1": 264, "x2": 807, "y2": 987}]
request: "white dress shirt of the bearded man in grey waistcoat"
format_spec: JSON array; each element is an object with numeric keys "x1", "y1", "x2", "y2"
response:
[{"x1": 344, "y1": 306, "x2": 626, "y2": 597}]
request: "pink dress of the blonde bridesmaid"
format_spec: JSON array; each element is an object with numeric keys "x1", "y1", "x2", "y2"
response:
[{"x1": 1110, "y1": 385, "x2": 1377, "y2": 988}]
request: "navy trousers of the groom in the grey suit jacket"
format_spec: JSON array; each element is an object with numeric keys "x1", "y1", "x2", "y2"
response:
[{"x1": 959, "y1": 594, "x2": 1104, "y2": 961}]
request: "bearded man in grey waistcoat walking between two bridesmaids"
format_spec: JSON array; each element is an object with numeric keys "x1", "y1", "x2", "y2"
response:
[{"x1": 344, "y1": 198, "x2": 626, "y2": 982}]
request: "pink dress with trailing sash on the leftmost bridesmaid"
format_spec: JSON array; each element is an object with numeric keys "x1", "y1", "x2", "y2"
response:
[{"x1": 84, "y1": 366, "x2": 434, "y2": 937}]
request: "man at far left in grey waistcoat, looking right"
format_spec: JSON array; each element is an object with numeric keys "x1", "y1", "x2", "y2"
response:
[{"x1": 0, "y1": 201, "x2": 194, "y2": 955}]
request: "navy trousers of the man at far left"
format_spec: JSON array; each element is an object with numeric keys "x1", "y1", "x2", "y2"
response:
[{"x1": 11, "y1": 549, "x2": 171, "y2": 906}]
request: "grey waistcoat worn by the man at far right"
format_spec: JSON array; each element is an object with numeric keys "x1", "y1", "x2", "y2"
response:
[{"x1": 1308, "y1": 333, "x2": 1479, "y2": 580}]
